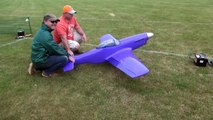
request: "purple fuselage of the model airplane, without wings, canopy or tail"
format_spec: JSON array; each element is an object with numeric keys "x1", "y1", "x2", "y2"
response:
[{"x1": 74, "y1": 33, "x2": 153, "y2": 64}]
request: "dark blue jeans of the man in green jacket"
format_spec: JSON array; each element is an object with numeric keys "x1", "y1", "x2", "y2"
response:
[{"x1": 35, "y1": 55, "x2": 68, "y2": 75}]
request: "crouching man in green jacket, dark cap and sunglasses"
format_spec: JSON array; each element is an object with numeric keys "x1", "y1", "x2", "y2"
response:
[{"x1": 28, "y1": 14, "x2": 75, "y2": 77}]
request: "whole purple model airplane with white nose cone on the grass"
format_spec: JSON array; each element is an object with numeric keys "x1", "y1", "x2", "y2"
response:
[{"x1": 64, "y1": 33, "x2": 154, "y2": 78}]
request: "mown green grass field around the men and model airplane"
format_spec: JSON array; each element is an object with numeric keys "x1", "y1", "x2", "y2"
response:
[{"x1": 0, "y1": 0, "x2": 213, "y2": 120}]
